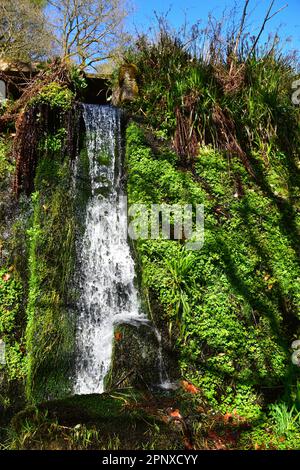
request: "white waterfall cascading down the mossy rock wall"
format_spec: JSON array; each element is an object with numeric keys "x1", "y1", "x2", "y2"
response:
[{"x1": 74, "y1": 104, "x2": 147, "y2": 394}]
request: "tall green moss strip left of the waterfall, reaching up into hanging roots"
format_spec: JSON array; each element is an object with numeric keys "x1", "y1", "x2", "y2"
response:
[{"x1": 26, "y1": 106, "x2": 91, "y2": 402}]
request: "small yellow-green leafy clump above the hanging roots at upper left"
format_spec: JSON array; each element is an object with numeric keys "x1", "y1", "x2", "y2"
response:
[{"x1": 30, "y1": 82, "x2": 74, "y2": 111}]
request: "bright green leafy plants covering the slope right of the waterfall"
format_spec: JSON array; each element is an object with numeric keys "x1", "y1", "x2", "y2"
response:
[{"x1": 127, "y1": 120, "x2": 300, "y2": 426}]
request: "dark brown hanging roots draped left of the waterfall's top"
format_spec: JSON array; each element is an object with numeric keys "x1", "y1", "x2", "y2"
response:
[{"x1": 0, "y1": 60, "x2": 79, "y2": 196}]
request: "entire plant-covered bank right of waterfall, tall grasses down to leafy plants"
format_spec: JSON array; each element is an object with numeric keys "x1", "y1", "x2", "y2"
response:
[{"x1": 120, "y1": 12, "x2": 300, "y2": 448}]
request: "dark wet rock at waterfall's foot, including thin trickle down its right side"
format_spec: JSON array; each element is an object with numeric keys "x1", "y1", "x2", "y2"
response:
[{"x1": 105, "y1": 280, "x2": 180, "y2": 390}]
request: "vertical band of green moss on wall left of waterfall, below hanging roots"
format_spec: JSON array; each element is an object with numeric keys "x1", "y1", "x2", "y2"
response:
[{"x1": 26, "y1": 149, "x2": 75, "y2": 401}]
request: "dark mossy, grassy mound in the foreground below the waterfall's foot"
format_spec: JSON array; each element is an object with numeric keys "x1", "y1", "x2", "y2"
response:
[{"x1": 7, "y1": 389, "x2": 188, "y2": 450}]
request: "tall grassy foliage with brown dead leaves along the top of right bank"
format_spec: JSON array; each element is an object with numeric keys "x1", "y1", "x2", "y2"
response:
[{"x1": 127, "y1": 25, "x2": 300, "y2": 170}]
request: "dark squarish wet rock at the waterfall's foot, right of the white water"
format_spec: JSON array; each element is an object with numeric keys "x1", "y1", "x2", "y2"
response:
[{"x1": 106, "y1": 323, "x2": 160, "y2": 388}]
